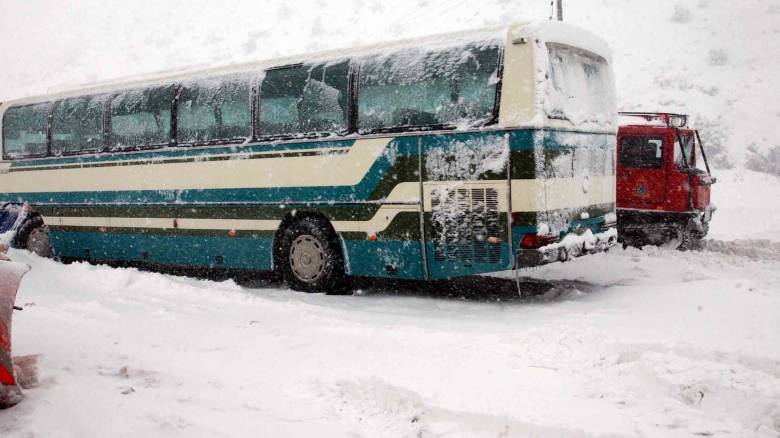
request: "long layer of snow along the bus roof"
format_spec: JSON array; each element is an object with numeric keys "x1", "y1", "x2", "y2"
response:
[{"x1": 0, "y1": 21, "x2": 611, "y2": 109}]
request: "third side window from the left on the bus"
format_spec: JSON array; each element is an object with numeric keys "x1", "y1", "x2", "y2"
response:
[{"x1": 110, "y1": 85, "x2": 173, "y2": 149}]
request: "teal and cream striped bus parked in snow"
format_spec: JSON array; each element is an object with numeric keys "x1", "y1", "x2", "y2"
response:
[{"x1": 0, "y1": 22, "x2": 616, "y2": 291}]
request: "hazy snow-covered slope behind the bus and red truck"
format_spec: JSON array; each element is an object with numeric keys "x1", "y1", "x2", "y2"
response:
[{"x1": 0, "y1": 0, "x2": 780, "y2": 167}]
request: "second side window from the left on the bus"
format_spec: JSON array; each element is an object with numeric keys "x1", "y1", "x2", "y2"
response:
[{"x1": 51, "y1": 96, "x2": 107, "y2": 155}]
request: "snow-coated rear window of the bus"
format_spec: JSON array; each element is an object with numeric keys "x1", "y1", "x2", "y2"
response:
[{"x1": 544, "y1": 44, "x2": 616, "y2": 125}]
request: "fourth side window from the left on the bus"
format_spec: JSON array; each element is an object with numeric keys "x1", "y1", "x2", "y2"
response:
[{"x1": 177, "y1": 77, "x2": 252, "y2": 143}]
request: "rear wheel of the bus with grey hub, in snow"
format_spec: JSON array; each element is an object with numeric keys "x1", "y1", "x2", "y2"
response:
[{"x1": 278, "y1": 217, "x2": 346, "y2": 293}]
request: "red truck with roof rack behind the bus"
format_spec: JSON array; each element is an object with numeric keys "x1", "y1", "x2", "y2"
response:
[{"x1": 617, "y1": 112, "x2": 715, "y2": 250}]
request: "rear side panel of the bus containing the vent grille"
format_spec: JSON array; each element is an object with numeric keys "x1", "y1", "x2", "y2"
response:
[{"x1": 420, "y1": 133, "x2": 511, "y2": 279}]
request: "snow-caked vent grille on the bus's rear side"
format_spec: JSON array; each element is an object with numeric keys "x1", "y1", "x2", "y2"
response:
[{"x1": 431, "y1": 188, "x2": 503, "y2": 266}]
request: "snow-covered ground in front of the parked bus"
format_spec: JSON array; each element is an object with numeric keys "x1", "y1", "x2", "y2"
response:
[{"x1": 0, "y1": 217, "x2": 780, "y2": 437}]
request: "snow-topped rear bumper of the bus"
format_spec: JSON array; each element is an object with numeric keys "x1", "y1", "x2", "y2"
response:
[{"x1": 517, "y1": 227, "x2": 618, "y2": 268}]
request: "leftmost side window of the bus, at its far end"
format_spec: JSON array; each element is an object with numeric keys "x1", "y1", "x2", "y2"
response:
[{"x1": 3, "y1": 103, "x2": 51, "y2": 159}]
